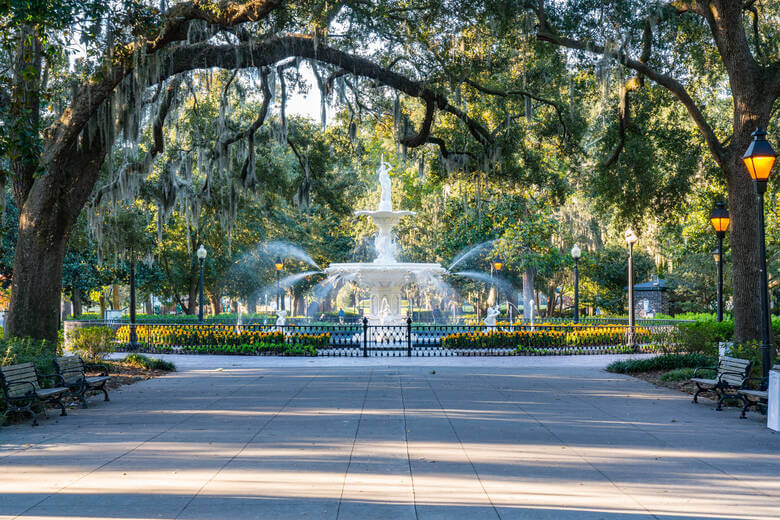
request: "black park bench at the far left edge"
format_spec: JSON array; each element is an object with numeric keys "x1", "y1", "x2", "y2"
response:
[{"x1": 0, "y1": 363, "x2": 68, "y2": 426}]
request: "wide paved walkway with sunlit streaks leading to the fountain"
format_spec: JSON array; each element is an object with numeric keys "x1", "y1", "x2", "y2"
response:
[{"x1": 0, "y1": 356, "x2": 780, "y2": 520}]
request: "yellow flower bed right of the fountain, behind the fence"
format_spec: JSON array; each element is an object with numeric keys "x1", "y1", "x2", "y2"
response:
[{"x1": 441, "y1": 324, "x2": 651, "y2": 349}]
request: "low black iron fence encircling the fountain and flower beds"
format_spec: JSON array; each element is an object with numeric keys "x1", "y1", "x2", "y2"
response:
[{"x1": 66, "y1": 320, "x2": 687, "y2": 356}]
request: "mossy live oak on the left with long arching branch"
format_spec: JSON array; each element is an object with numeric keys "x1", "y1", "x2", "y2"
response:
[{"x1": 0, "y1": 0, "x2": 516, "y2": 339}]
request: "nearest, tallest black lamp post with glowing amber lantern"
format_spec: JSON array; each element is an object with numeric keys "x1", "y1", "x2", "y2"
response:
[{"x1": 742, "y1": 128, "x2": 777, "y2": 378}]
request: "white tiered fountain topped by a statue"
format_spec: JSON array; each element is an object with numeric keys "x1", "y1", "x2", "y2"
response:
[{"x1": 325, "y1": 159, "x2": 446, "y2": 325}]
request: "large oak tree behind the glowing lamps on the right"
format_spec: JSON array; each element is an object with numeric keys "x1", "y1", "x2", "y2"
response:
[{"x1": 525, "y1": 0, "x2": 780, "y2": 346}]
